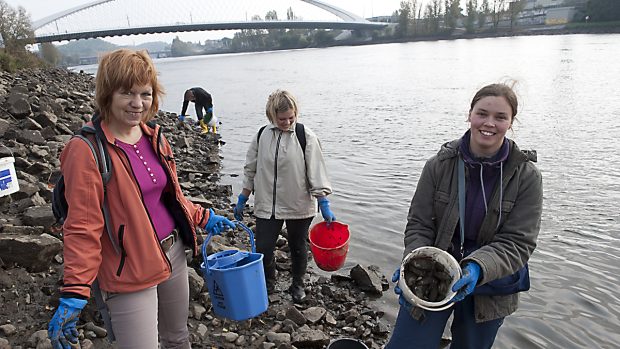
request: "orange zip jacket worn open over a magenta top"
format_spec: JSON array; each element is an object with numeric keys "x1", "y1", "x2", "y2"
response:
[{"x1": 60, "y1": 122, "x2": 209, "y2": 297}]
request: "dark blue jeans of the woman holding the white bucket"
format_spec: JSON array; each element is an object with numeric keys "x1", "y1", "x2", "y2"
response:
[{"x1": 385, "y1": 296, "x2": 504, "y2": 349}]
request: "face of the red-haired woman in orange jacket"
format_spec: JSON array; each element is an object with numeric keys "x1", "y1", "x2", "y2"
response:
[{"x1": 109, "y1": 85, "x2": 153, "y2": 129}]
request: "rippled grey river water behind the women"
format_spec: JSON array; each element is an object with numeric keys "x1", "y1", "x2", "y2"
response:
[{"x1": 77, "y1": 34, "x2": 620, "y2": 348}]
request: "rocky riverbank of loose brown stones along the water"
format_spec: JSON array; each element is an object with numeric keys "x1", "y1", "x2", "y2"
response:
[{"x1": 0, "y1": 69, "x2": 389, "y2": 349}]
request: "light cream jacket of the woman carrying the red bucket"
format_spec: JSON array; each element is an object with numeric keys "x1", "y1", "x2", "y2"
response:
[{"x1": 243, "y1": 124, "x2": 332, "y2": 219}]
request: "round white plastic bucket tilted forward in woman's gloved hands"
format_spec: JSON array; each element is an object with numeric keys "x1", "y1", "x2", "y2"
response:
[{"x1": 398, "y1": 246, "x2": 462, "y2": 311}]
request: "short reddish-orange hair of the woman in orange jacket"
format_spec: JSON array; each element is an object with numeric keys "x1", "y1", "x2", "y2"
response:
[{"x1": 95, "y1": 49, "x2": 164, "y2": 122}]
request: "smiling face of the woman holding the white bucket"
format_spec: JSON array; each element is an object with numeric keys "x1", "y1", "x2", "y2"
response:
[{"x1": 467, "y1": 96, "x2": 513, "y2": 157}]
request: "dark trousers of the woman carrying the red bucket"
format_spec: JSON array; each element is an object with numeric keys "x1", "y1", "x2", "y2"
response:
[{"x1": 256, "y1": 217, "x2": 314, "y2": 284}]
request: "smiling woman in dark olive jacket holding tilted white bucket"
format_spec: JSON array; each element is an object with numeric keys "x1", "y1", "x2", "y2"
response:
[{"x1": 386, "y1": 84, "x2": 542, "y2": 349}]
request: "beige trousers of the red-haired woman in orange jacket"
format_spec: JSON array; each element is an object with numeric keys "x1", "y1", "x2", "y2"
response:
[{"x1": 103, "y1": 241, "x2": 191, "y2": 349}]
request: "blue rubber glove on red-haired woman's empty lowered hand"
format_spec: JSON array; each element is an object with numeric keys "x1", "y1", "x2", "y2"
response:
[{"x1": 47, "y1": 298, "x2": 88, "y2": 349}]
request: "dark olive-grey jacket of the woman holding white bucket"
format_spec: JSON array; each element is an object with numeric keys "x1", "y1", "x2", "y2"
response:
[{"x1": 404, "y1": 139, "x2": 543, "y2": 322}]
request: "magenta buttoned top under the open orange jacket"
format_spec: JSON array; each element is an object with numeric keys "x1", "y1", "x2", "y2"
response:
[{"x1": 115, "y1": 135, "x2": 176, "y2": 240}]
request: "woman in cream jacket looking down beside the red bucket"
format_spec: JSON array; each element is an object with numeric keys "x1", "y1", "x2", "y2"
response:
[{"x1": 234, "y1": 90, "x2": 336, "y2": 303}]
